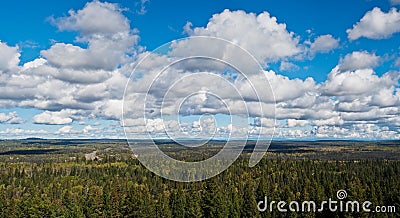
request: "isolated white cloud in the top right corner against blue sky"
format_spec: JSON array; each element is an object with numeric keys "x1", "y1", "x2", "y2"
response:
[{"x1": 346, "y1": 7, "x2": 400, "y2": 40}]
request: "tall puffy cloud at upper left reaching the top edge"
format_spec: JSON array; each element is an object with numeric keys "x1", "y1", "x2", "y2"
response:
[{"x1": 41, "y1": 1, "x2": 138, "y2": 71}]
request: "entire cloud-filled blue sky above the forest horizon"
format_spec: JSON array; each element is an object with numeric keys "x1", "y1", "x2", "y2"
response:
[{"x1": 0, "y1": 0, "x2": 400, "y2": 140}]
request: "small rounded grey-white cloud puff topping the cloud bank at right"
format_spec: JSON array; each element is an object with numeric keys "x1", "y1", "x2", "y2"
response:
[{"x1": 339, "y1": 51, "x2": 380, "y2": 71}]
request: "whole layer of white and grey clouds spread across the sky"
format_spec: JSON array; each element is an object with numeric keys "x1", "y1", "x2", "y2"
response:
[{"x1": 0, "y1": 1, "x2": 400, "y2": 138}]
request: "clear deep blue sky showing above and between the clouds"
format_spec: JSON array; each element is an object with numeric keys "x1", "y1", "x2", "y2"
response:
[{"x1": 0, "y1": 0, "x2": 399, "y2": 82}]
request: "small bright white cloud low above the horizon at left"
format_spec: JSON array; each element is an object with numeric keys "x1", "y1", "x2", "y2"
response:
[{"x1": 33, "y1": 111, "x2": 73, "y2": 125}]
